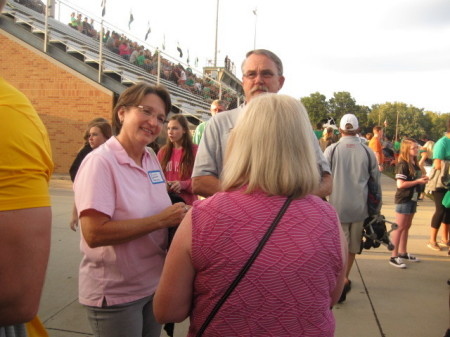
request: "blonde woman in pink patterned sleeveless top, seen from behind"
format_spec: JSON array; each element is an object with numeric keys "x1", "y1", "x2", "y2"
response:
[{"x1": 154, "y1": 94, "x2": 346, "y2": 337}]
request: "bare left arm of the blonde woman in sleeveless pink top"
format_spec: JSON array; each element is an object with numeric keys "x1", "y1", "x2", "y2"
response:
[{"x1": 153, "y1": 212, "x2": 195, "y2": 323}]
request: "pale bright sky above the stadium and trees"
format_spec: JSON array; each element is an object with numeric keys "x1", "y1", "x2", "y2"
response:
[{"x1": 60, "y1": 0, "x2": 450, "y2": 113}]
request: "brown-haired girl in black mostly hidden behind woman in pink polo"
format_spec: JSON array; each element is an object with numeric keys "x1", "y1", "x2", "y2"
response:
[{"x1": 69, "y1": 117, "x2": 112, "y2": 231}]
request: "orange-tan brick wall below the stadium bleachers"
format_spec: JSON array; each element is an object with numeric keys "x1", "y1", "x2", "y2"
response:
[{"x1": 0, "y1": 30, "x2": 113, "y2": 173}]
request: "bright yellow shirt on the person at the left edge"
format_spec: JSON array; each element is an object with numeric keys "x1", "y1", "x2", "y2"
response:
[{"x1": 0, "y1": 77, "x2": 53, "y2": 211}]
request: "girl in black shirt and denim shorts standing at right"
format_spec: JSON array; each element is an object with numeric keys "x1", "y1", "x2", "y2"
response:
[{"x1": 389, "y1": 139, "x2": 428, "y2": 268}]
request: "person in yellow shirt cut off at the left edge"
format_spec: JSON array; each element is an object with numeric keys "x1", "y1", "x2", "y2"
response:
[{"x1": 0, "y1": 32, "x2": 53, "y2": 337}]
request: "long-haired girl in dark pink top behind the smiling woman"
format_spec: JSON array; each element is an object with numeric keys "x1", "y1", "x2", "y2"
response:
[{"x1": 158, "y1": 115, "x2": 198, "y2": 205}]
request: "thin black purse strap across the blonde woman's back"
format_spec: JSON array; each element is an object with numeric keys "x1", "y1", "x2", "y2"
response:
[{"x1": 197, "y1": 197, "x2": 292, "y2": 337}]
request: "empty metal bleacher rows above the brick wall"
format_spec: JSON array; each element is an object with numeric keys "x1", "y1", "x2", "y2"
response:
[{"x1": 2, "y1": 2, "x2": 214, "y2": 123}]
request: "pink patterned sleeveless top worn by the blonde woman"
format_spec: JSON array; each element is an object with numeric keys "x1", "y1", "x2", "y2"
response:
[{"x1": 188, "y1": 191, "x2": 343, "y2": 337}]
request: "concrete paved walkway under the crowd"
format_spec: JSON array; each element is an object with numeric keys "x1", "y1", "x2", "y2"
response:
[{"x1": 39, "y1": 176, "x2": 450, "y2": 337}]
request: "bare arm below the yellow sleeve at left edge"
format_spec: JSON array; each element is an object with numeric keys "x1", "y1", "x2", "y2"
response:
[{"x1": 0, "y1": 207, "x2": 52, "y2": 326}]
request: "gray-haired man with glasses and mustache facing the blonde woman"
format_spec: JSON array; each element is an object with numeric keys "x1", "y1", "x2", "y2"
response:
[{"x1": 192, "y1": 49, "x2": 332, "y2": 197}]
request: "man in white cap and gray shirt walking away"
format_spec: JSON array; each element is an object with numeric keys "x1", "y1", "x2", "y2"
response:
[{"x1": 324, "y1": 114, "x2": 381, "y2": 303}]
